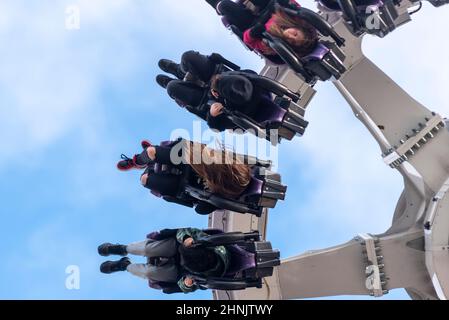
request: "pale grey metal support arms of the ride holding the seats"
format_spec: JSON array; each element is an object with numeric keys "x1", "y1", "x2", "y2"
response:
[{"x1": 209, "y1": 1, "x2": 449, "y2": 299}]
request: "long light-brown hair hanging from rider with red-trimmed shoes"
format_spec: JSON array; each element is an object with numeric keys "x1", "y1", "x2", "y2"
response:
[{"x1": 187, "y1": 143, "x2": 251, "y2": 199}]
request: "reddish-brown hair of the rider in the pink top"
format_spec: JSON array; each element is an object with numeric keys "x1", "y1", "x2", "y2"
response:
[{"x1": 268, "y1": 9, "x2": 318, "y2": 57}]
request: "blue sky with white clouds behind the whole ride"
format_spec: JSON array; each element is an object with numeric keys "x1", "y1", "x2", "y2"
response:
[{"x1": 0, "y1": 0, "x2": 449, "y2": 299}]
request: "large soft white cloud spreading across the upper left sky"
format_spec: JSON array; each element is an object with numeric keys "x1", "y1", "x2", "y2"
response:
[{"x1": 0, "y1": 0, "x2": 257, "y2": 168}]
